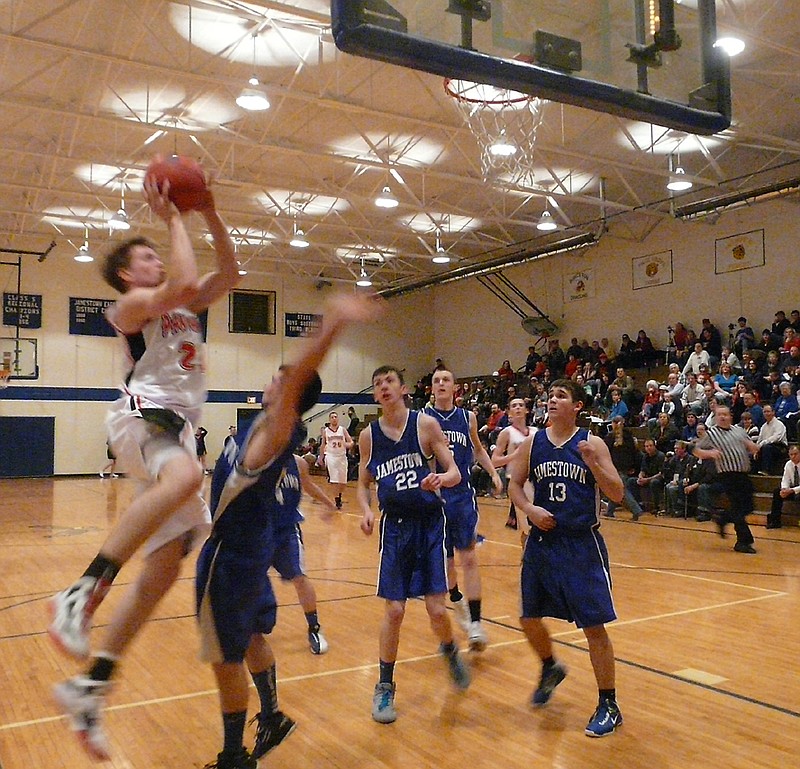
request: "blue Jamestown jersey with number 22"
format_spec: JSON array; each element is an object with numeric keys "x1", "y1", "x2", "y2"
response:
[{"x1": 367, "y1": 411, "x2": 442, "y2": 517}]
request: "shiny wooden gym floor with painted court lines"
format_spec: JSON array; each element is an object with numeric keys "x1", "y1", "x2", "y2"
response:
[{"x1": 0, "y1": 478, "x2": 800, "y2": 769}]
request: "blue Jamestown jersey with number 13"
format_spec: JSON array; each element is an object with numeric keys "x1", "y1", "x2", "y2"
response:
[{"x1": 528, "y1": 429, "x2": 600, "y2": 532}]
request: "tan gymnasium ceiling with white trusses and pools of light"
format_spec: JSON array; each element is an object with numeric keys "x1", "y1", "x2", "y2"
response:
[{"x1": 0, "y1": 0, "x2": 800, "y2": 290}]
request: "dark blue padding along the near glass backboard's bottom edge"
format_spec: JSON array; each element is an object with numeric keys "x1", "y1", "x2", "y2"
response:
[{"x1": 331, "y1": 0, "x2": 731, "y2": 134}]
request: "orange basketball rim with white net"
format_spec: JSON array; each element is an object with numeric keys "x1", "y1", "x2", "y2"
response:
[{"x1": 444, "y1": 77, "x2": 545, "y2": 187}]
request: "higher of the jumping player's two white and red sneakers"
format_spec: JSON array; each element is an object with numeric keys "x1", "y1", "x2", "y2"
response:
[{"x1": 47, "y1": 576, "x2": 110, "y2": 659}]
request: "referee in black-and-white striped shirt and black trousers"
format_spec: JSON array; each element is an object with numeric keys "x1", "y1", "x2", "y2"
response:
[{"x1": 694, "y1": 404, "x2": 758, "y2": 554}]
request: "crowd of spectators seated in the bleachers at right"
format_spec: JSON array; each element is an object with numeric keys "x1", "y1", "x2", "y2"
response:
[{"x1": 424, "y1": 310, "x2": 800, "y2": 520}]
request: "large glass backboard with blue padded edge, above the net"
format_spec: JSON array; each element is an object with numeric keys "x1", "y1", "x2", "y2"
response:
[{"x1": 331, "y1": 0, "x2": 730, "y2": 134}]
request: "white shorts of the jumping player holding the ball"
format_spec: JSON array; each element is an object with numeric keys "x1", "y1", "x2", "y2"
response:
[{"x1": 106, "y1": 396, "x2": 211, "y2": 556}]
